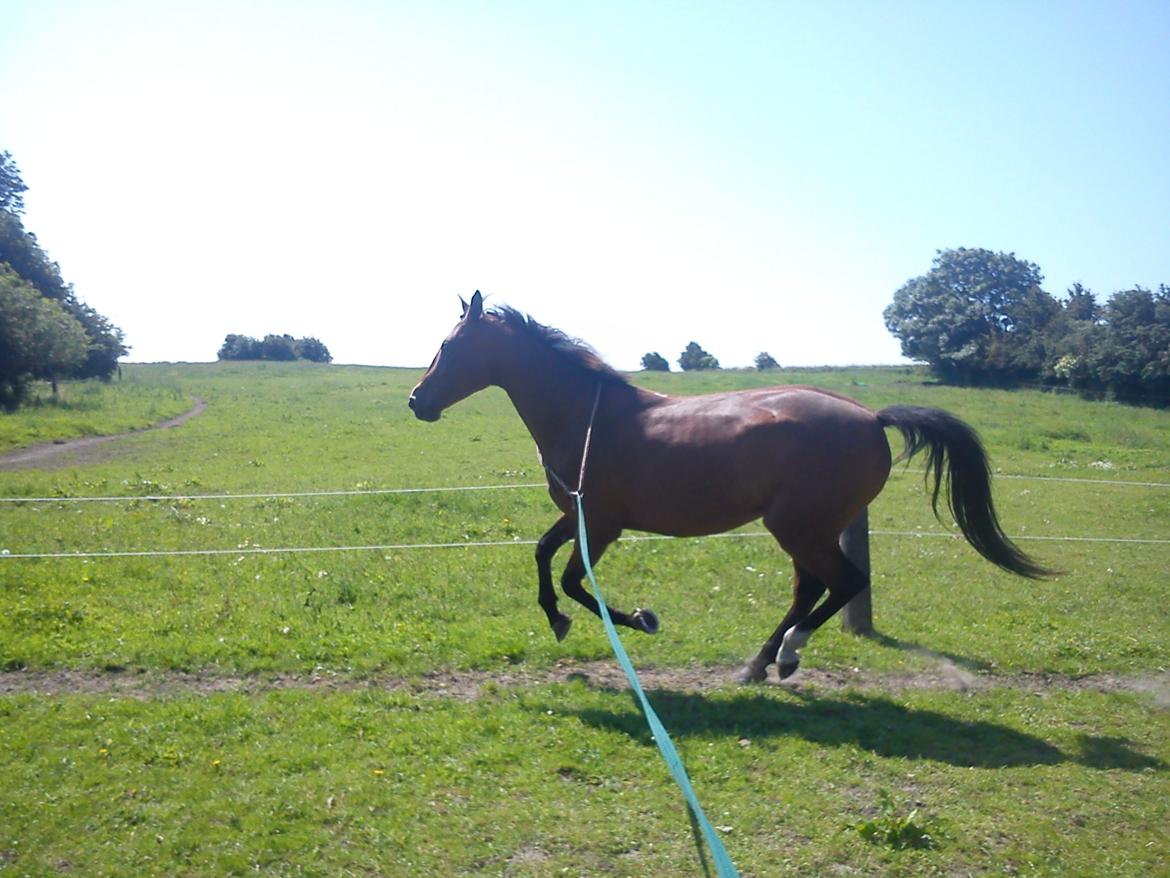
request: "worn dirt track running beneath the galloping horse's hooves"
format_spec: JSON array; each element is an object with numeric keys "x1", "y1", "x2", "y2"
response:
[{"x1": 0, "y1": 661, "x2": 1170, "y2": 707}]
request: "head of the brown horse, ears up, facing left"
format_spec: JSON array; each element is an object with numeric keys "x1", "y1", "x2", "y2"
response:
[{"x1": 410, "y1": 290, "x2": 491, "y2": 420}]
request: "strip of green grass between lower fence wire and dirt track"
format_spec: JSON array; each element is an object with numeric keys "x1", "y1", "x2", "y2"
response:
[{"x1": 0, "y1": 526, "x2": 1170, "y2": 675}]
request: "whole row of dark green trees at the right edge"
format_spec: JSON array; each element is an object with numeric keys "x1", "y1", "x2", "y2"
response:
[{"x1": 883, "y1": 247, "x2": 1170, "y2": 403}]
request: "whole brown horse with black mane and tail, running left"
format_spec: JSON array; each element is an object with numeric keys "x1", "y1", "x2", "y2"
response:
[{"x1": 410, "y1": 291, "x2": 1047, "y2": 682}]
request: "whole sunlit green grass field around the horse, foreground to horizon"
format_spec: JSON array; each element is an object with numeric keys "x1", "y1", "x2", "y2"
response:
[{"x1": 0, "y1": 364, "x2": 1170, "y2": 876}]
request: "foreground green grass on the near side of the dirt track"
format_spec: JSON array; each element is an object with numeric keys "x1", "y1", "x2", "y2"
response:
[{"x1": 0, "y1": 682, "x2": 1170, "y2": 878}]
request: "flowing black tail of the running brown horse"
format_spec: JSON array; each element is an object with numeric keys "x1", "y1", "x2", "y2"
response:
[{"x1": 878, "y1": 405, "x2": 1052, "y2": 579}]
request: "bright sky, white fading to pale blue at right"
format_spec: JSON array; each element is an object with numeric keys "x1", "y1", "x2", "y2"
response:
[{"x1": 0, "y1": 0, "x2": 1170, "y2": 370}]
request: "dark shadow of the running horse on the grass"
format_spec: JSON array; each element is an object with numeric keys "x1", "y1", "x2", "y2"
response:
[{"x1": 558, "y1": 690, "x2": 1168, "y2": 771}]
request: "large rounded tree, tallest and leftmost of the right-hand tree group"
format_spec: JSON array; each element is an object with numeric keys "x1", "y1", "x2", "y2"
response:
[{"x1": 883, "y1": 247, "x2": 1060, "y2": 384}]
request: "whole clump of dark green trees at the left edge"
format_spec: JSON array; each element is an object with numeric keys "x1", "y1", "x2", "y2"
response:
[{"x1": 0, "y1": 152, "x2": 128, "y2": 411}]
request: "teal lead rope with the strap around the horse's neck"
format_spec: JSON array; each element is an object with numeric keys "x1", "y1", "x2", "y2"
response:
[{"x1": 561, "y1": 384, "x2": 739, "y2": 878}]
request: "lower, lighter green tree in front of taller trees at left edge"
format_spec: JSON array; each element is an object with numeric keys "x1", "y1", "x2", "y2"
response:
[{"x1": 0, "y1": 265, "x2": 88, "y2": 411}]
